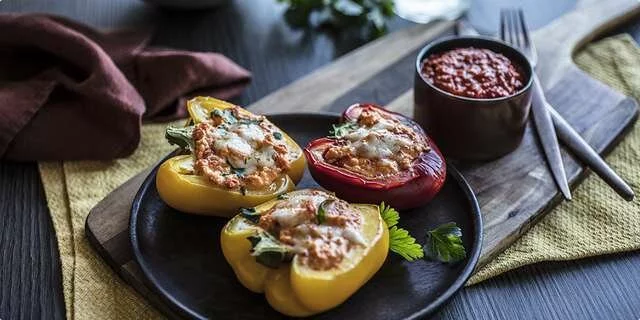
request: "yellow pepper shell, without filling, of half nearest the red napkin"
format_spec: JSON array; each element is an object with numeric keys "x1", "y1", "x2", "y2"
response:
[{"x1": 156, "y1": 97, "x2": 306, "y2": 217}]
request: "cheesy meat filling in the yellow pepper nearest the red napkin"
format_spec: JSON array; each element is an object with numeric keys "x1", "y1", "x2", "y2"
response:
[{"x1": 192, "y1": 107, "x2": 299, "y2": 191}]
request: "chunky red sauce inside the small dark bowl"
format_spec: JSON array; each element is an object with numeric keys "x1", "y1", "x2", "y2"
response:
[{"x1": 422, "y1": 47, "x2": 524, "y2": 99}]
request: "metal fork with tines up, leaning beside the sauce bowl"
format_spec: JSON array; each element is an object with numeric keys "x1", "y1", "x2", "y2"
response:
[{"x1": 500, "y1": 9, "x2": 571, "y2": 200}]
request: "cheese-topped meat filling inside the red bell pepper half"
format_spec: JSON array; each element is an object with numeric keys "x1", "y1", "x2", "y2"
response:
[{"x1": 322, "y1": 108, "x2": 429, "y2": 179}]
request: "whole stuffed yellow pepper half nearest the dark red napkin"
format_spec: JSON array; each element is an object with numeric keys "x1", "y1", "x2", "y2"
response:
[{"x1": 156, "y1": 97, "x2": 305, "y2": 217}]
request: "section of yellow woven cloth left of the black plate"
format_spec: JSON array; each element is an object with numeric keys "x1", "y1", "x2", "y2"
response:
[{"x1": 39, "y1": 124, "x2": 175, "y2": 319}]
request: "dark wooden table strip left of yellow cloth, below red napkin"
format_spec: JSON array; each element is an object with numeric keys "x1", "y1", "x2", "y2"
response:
[{"x1": 0, "y1": 163, "x2": 64, "y2": 319}]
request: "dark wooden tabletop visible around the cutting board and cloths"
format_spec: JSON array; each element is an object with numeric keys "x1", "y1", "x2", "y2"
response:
[{"x1": 0, "y1": 0, "x2": 640, "y2": 319}]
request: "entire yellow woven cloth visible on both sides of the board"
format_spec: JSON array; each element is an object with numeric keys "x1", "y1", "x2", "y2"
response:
[{"x1": 40, "y1": 36, "x2": 640, "y2": 319}]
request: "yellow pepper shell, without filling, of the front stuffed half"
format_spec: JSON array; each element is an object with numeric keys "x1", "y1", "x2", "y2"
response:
[{"x1": 220, "y1": 189, "x2": 389, "y2": 317}]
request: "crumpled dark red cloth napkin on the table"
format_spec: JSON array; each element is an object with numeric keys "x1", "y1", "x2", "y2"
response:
[{"x1": 0, "y1": 14, "x2": 250, "y2": 160}]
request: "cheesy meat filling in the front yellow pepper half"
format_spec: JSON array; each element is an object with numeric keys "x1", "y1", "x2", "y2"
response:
[{"x1": 259, "y1": 191, "x2": 366, "y2": 270}]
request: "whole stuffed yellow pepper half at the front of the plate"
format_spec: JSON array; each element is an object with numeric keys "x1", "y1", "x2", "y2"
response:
[{"x1": 221, "y1": 189, "x2": 389, "y2": 316}]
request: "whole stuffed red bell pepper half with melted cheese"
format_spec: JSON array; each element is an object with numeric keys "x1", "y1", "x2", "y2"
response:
[{"x1": 304, "y1": 104, "x2": 446, "y2": 209}]
